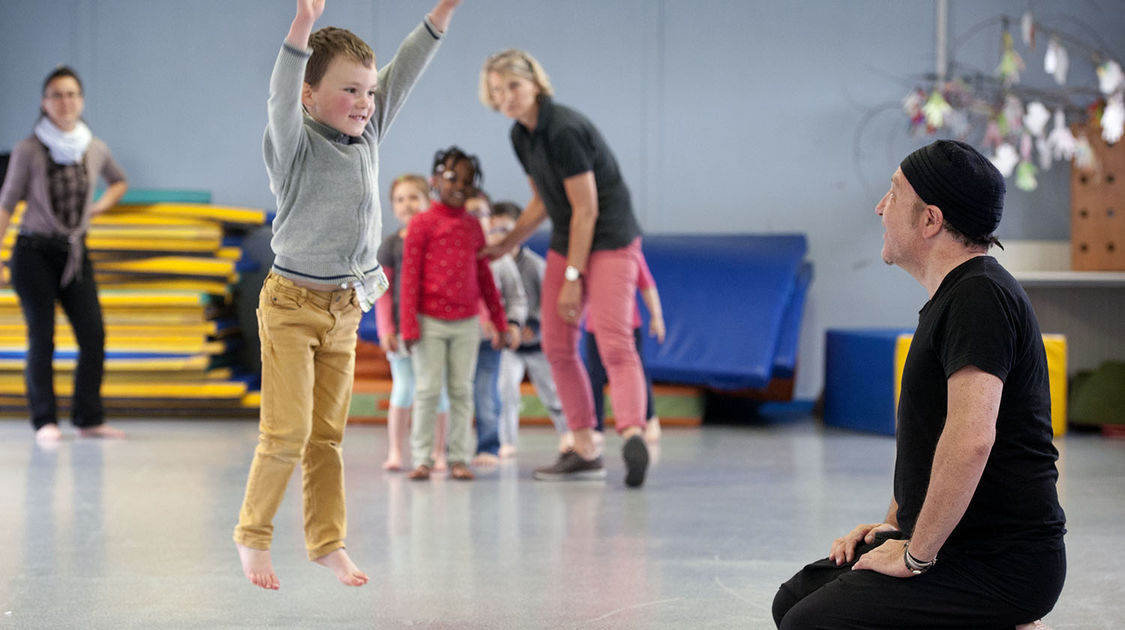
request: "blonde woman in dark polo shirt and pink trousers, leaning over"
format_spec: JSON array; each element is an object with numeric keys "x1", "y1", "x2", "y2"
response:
[{"x1": 480, "y1": 50, "x2": 648, "y2": 487}]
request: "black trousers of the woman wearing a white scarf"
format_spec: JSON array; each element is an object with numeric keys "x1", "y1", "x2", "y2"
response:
[{"x1": 10, "y1": 234, "x2": 106, "y2": 430}]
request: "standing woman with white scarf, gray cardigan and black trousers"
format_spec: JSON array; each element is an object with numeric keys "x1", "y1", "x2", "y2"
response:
[{"x1": 0, "y1": 66, "x2": 128, "y2": 441}]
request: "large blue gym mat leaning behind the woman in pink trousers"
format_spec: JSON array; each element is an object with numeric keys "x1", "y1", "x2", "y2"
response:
[{"x1": 529, "y1": 232, "x2": 812, "y2": 390}]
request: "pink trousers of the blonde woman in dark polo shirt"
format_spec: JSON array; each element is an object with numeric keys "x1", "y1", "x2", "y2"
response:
[{"x1": 541, "y1": 237, "x2": 646, "y2": 433}]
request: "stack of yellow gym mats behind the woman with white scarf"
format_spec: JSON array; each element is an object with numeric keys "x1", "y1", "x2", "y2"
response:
[{"x1": 0, "y1": 190, "x2": 267, "y2": 417}]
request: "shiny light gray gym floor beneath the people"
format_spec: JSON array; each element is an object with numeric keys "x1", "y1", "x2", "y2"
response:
[{"x1": 0, "y1": 420, "x2": 1125, "y2": 630}]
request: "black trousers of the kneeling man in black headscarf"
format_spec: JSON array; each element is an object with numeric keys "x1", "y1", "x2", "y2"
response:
[{"x1": 773, "y1": 532, "x2": 1067, "y2": 630}]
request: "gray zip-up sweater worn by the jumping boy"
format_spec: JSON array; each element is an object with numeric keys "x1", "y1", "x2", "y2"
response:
[{"x1": 262, "y1": 20, "x2": 440, "y2": 285}]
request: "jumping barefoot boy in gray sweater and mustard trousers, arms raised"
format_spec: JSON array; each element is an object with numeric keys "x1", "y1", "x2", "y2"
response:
[{"x1": 234, "y1": 0, "x2": 460, "y2": 590}]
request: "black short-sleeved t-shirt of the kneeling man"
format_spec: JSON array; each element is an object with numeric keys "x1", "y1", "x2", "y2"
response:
[{"x1": 894, "y1": 257, "x2": 1065, "y2": 551}]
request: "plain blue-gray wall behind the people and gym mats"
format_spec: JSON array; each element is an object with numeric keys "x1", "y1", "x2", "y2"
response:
[{"x1": 0, "y1": 0, "x2": 1125, "y2": 398}]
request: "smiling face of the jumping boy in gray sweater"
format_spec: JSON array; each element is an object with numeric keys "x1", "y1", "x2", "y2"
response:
[{"x1": 300, "y1": 55, "x2": 379, "y2": 136}]
